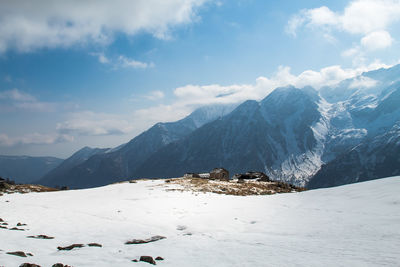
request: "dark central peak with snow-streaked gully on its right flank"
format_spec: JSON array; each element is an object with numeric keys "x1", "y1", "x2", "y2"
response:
[{"x1": 134, "y1": 87, "x2": 321, "y2": 186}]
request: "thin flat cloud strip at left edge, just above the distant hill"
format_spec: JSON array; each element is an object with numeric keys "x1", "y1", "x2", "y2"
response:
[{"x1": 0, "y1": 133, "x2": 74, "y2": 147}]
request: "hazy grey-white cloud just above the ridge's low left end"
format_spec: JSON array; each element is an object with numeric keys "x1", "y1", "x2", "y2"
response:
[{"x1": 57, "y1": 111, "x2": 133, "y2": 136}]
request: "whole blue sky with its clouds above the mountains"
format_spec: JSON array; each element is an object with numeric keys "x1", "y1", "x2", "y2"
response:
[{"x1": 0, "y1": 0, "x2": 400, "y2": 158}]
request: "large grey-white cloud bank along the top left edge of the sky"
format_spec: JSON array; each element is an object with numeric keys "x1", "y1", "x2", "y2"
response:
[{"x1": 0, "y1": 0, "x2": 205, "y2": 52}]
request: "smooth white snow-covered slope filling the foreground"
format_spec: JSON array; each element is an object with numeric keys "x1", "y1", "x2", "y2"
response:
[{"x1": 0, "y1": 177, "x2": 400, "y2": 267}]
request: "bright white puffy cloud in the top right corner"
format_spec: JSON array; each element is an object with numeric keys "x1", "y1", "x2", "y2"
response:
[{"x1": 286, "y1": 0, "x2": 400, "y2": 59}]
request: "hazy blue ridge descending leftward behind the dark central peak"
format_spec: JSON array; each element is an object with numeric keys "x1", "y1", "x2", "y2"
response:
[{"x1": 39, "y1": 105, "x2": 235, "y2": 188}]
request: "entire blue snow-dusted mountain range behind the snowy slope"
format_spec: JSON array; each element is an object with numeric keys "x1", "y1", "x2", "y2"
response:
[{"x1": 1, "y1": 65, "x2": 400, "y2": 188}]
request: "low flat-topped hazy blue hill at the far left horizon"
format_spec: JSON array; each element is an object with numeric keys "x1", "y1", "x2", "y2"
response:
[{"x1": 0, "y1": 156, "x2": 63, "y2": 183}]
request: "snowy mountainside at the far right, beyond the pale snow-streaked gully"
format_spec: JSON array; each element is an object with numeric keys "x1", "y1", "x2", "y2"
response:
[{"x1": 308, "y1": 66, "x2": 400, "y2": 188}]
